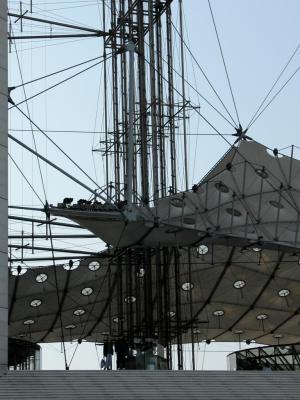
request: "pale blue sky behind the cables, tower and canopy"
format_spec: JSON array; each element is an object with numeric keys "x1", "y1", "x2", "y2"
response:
[{"x1": 9, "y1": 0, "x2": 300, "y2": 369}]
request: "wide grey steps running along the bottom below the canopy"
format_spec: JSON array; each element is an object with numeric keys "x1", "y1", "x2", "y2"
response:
[{"x1": 0, "y1": 371, "x2": 300, "y2": 400}]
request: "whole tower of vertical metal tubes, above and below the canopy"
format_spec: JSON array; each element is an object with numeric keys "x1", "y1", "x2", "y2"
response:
[{"x1": 99, "y1": 0, "x2": 194, "y2": 369}]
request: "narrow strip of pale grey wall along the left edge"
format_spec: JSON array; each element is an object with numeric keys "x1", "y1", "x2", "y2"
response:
[{"x1": 0, "y1": 0, "x2": 8, "y2": 370}]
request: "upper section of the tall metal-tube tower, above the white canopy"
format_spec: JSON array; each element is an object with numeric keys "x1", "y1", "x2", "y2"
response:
[{"x1": 103, "y1": 0, "x2": 177, "y2": 205}]
